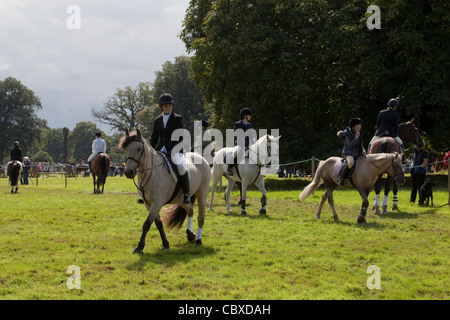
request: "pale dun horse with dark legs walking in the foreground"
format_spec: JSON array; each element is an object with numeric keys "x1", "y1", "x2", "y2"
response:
[{"x1": 119, "y1": 129, "x2": 211, "y2": 254}]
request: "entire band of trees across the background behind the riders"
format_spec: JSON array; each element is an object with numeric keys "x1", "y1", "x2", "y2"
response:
[{"x1": 0, "y1": 0, "x2": 450, "y2": 163}]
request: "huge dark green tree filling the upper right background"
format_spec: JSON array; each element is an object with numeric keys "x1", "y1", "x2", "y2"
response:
[{"x1": 181, "y1": 0, "x2": 450, "y2": 161}]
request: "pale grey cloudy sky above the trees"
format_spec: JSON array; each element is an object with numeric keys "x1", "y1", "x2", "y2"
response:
[{"x1": 0, "y1": 0, "x2": 189, "y2": 132}]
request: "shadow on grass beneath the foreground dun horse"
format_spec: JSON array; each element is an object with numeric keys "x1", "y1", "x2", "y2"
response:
[{"x1": 126, "y1": 243, "x2": 216, "y2": 270}]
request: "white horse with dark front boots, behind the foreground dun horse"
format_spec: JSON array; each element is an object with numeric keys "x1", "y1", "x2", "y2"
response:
[{"x1": 209, "y1": 134, "x2": 281, "y2": 215}]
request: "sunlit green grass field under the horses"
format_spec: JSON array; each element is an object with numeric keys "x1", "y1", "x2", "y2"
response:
[{"x1": 0, "y1": 172, "x2": 450, "y2": 300}]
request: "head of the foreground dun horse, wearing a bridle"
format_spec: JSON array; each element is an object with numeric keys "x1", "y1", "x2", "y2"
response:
[{"x1": 118, "y1": 129, "x2": 145, "y2": 179}]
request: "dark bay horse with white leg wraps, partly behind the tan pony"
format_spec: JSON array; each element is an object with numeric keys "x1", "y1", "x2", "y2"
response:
[{"x1": 368, "y1": 118, "x2": 425, "y2": 214}]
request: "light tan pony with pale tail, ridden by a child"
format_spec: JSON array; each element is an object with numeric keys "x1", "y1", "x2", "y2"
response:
[{"x1": 300, "y1": 152, "x2": 405, "y2": 223}]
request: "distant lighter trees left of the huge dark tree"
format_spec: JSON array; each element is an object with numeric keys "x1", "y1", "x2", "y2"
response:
[{"x1": 0, "y1": 56, "x2": 209, "y2": 164}]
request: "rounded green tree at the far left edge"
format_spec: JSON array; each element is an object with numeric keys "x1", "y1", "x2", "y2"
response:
[{"x1": 0, "y1": 77, "x2": 46, "y2": 164}]
